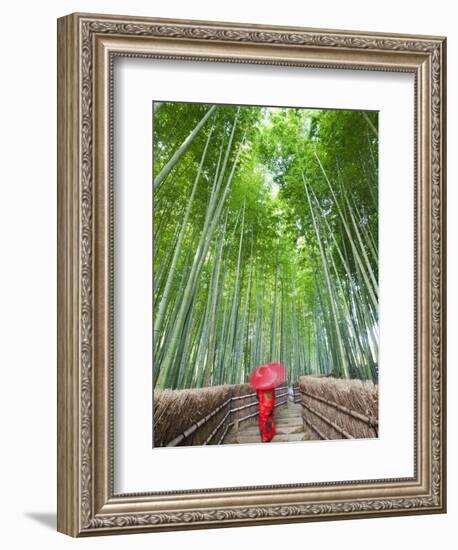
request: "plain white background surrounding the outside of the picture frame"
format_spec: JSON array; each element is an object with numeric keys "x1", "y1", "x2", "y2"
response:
[{"x1": 0, "y1": 0, "x2": 452, "y2": 550}]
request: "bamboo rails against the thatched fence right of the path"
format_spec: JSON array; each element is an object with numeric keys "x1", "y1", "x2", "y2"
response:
[{"x1": 293, "y1": 385, "x2": 378, "y2": 439}]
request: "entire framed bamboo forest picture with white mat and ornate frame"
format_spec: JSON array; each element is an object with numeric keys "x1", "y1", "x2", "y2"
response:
[{"x1": 58, "y1": 14, "x2": 446, "y2": 536}]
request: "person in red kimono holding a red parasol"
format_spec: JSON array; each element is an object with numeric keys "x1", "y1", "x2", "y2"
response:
[{"x1": 248, "y1": 363, "x2": 285, "y2": 443}]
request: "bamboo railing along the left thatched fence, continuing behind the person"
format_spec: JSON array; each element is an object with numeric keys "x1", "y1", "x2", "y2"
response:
[{"x1": 166, "y1": 385, "x2": 288, "y2": 447}]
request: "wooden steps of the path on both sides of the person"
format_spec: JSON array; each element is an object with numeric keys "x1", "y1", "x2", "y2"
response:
[{"x1": 224, "y1": 401, "x2": 312, "y2": 444}]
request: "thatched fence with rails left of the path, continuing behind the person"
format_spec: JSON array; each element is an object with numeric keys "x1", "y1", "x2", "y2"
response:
[{"x1": 153, "y1": 384, "x2": 288, "y2": 447}]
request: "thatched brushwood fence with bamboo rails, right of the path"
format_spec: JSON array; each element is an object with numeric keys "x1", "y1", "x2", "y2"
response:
[{"x1": 294, "y1": 376, "x2": 378, "y2": 439}]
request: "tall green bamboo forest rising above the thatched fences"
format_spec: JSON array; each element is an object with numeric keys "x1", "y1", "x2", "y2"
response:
[{"x1": 153, "y1": 102, "x2": 378, "y2": 389}]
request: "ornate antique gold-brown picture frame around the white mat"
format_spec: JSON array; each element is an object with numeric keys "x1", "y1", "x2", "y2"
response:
[{"x1": 58, "y1": 14, "x2": 446, "y2": 536}]
